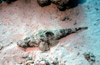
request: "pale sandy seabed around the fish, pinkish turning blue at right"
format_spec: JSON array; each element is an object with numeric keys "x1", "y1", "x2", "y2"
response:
[{"x1": 0, "y1": 0, "x2": 100, "y2": 65}]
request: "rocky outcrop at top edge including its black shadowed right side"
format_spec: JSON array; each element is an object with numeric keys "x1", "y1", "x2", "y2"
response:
[{"x1": 37, "y1": 0, "x2": 78, "y2": 11}]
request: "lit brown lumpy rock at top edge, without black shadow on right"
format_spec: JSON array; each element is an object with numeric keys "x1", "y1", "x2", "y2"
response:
[{"x1": 37, "y1": 0, "x2": 69, "y2": 11}]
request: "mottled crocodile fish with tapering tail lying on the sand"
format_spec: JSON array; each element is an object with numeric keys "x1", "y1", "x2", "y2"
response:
[{"x1": 17, "y1": 27, "x2": 88, "y2": 51}]
